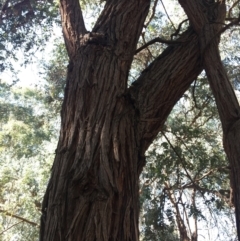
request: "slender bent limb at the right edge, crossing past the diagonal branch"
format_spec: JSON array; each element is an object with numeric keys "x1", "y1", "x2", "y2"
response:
[{"x1": 179, "y1": 0, "x2": 240, "y2": 237}]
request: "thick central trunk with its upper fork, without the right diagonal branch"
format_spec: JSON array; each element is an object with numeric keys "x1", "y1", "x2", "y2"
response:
[{"x1": 41, "y1": 1, "x2": 149, "y2": 241}]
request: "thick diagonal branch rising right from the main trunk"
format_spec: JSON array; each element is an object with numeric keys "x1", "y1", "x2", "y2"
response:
[{"x1": 129, "y1": 29, "x2": 202, "y2": 151}]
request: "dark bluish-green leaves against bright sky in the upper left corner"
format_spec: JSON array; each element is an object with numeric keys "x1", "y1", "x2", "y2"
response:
[{"x1": 0, "y1": 0, "x2": 60, "y2": 72}]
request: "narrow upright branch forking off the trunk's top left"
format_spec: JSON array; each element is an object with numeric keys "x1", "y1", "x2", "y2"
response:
[{"x1": 60, "y1": 0, "x2": 87, "y2": 56}]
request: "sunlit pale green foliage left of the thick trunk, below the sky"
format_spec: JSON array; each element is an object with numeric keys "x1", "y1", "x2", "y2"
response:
[{"x1": 0, "y1": 83, "x2": 59, "y2": 241}]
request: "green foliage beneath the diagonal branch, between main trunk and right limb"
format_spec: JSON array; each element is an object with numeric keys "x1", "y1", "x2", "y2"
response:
[{"x1": 141, "y1": 79, "x2": 233, "y2": 240}]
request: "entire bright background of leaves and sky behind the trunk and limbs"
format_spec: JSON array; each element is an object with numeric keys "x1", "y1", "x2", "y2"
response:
[{"x1": 0, "y1": 0, "x2": 240, "y2": 241}]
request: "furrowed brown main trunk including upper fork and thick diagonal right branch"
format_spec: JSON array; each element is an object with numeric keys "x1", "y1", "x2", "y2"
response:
[{"x1": 40, "y1": 0, "x2": 202, "y2": 241}]
